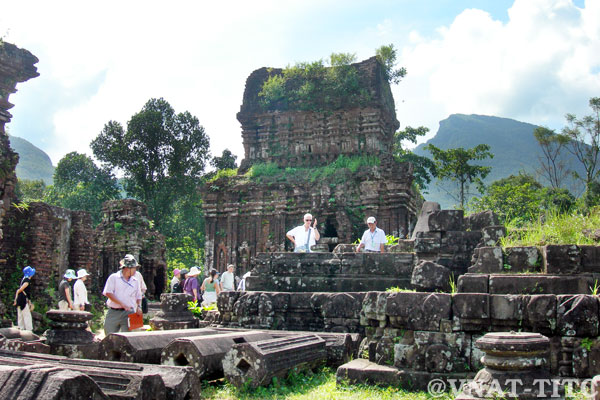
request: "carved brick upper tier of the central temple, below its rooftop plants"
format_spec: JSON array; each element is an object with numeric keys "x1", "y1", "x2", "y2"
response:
[{"x1": 237, "y1": 57, "x2": 399, "y2": 171}]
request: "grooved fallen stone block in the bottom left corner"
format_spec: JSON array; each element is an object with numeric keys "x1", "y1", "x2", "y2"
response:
[{"x1": 0, "y1": 363, "x2": 109, "y2": 400}]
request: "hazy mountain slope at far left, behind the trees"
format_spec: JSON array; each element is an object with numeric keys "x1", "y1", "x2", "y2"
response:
[{"x1": 8, "y1": 135, "x2": 54, "y2": 185}]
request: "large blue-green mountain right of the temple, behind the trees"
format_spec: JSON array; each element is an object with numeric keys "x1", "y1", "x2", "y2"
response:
[{"x1": 414, "y1": 114, "x2": 581, "y2": 208}]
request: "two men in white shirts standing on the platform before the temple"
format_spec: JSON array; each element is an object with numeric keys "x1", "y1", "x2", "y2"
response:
[{"x1": 285, "y1": 214, "x2": 387, "y2": 253}]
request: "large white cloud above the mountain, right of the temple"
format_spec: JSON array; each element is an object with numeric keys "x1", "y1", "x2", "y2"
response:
[{"x1": 395, "y1": 0, "x2": 600, "y2": 143}]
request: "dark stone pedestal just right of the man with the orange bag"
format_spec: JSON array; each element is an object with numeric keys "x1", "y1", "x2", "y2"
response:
[{"x1": 150, "y1": 293, "x2": 198, "y2": 331}]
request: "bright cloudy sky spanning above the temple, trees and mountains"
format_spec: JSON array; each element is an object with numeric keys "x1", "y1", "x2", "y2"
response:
[{"x1": 0, "y1": 0, "x2": 600, "y2": 165}]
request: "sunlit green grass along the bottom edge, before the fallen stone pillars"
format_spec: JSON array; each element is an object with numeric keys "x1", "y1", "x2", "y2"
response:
[{"x1": 201, "y1": 367, "x2": 438, "y2": 400}]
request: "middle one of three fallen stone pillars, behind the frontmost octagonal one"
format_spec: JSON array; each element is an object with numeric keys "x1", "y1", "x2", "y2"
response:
[{"x1": 160, "y1": 331, "x2": 273, "y2": 379}]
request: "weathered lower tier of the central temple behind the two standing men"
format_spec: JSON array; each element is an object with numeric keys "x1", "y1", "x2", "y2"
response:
[{"x1": 203, "y1": 165, "x2": 415, "y2": 275}]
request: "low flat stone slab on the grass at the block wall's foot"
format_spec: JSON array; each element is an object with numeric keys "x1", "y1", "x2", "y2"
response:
[{"x1": 336, "y1": 358, "x2": 474, "y2": 390}]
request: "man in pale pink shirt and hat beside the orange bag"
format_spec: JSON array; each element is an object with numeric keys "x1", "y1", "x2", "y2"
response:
[{"x1": 102, "y1": 254, "x2": 142, "y2": 335}]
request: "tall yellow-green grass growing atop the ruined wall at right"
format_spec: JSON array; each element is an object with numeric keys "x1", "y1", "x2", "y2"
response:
[{"x1": 500, "y1": 208, "x2": 600, "y2": 247}]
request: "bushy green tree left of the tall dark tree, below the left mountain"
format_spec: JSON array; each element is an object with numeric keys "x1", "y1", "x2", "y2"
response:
[{"x1": 45, "y1": 152, "x2": 120, "y2": 224}]
